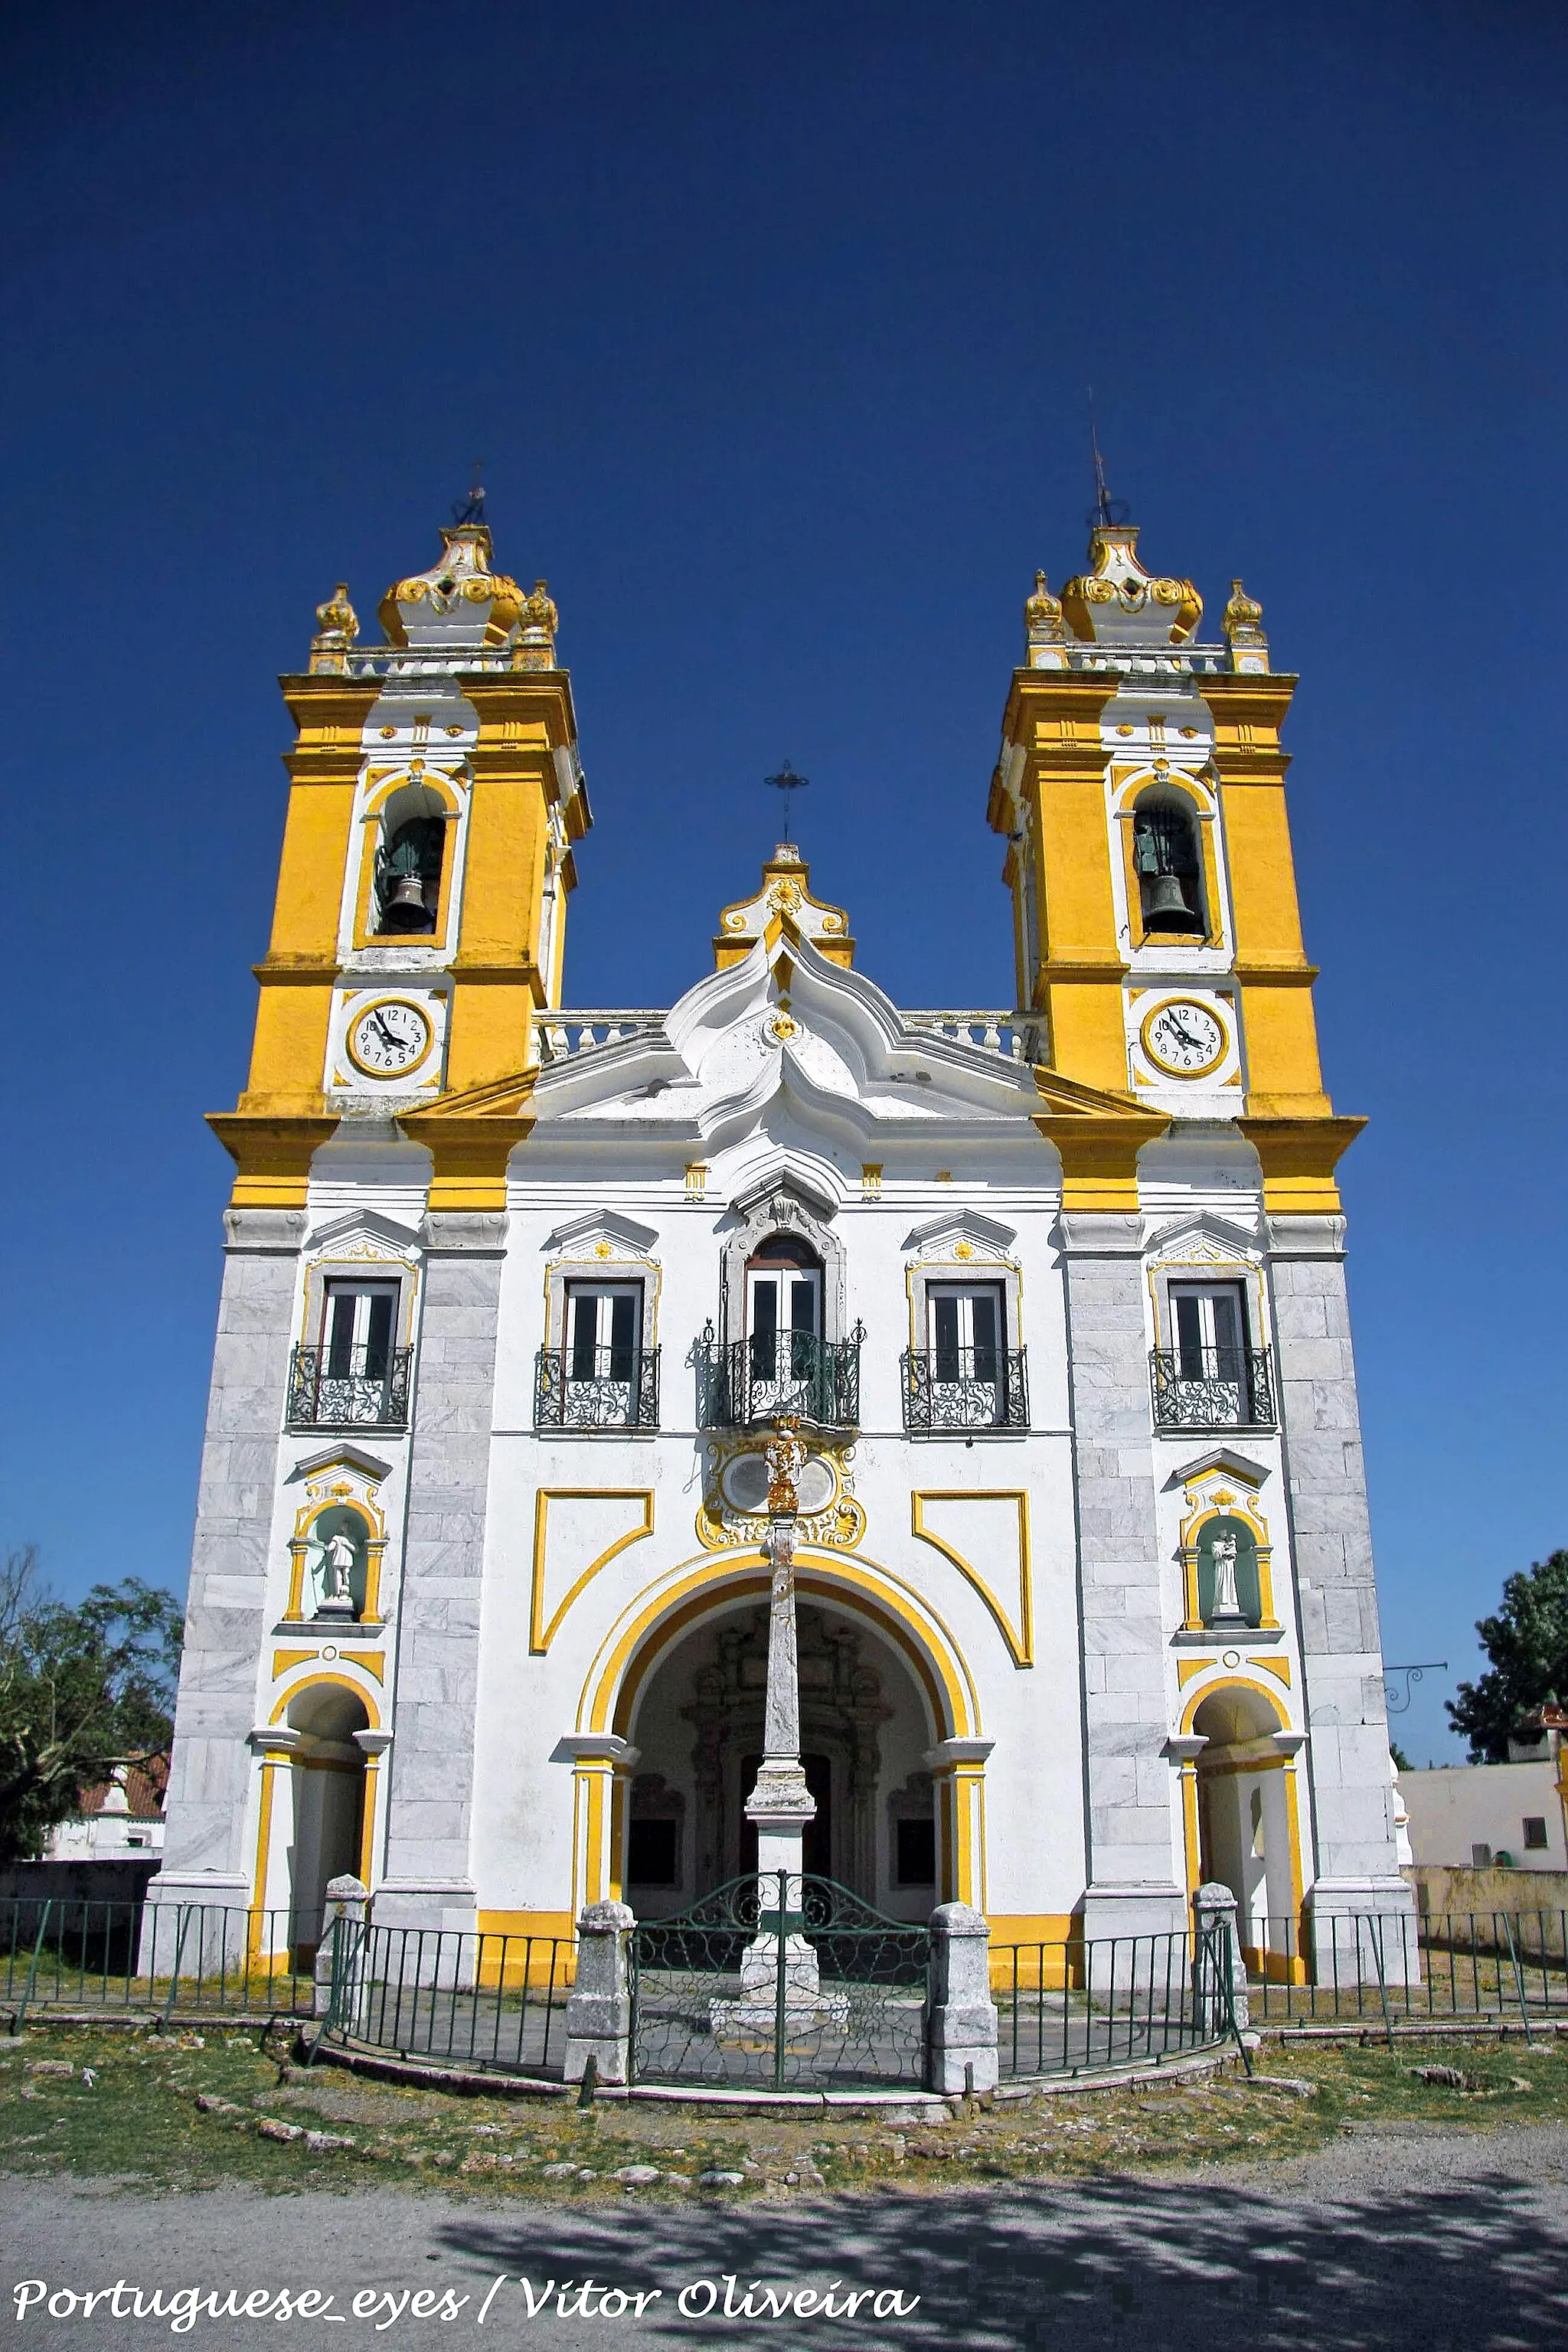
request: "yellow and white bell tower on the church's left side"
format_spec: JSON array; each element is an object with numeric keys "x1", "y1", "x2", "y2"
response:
[{"x1": 211, "y1": 510, "x2": 593, "y2": 1209}]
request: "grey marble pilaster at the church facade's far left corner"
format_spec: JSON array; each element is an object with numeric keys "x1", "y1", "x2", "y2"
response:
[{"x1": 148, "y1": 1209, "x2": 305, "y2": 1905}]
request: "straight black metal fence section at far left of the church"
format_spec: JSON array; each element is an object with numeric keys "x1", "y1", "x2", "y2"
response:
[{"x1": 0, "y1": 1896, "x2": 322, "y2": 2023}]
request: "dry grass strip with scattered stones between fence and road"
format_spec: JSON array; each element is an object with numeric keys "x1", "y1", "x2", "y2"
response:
[{"x1": 0, "y1": 2027, "x2": 1568, "y2": 2201}]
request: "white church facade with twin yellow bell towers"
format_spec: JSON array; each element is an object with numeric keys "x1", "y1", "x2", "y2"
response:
[{"x1": 151, "y1": 515, "x2": 1408, "y2": 1968}]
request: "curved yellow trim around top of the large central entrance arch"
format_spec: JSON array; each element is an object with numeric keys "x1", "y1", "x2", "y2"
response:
[{"x1": 576, "y1": 1550, "x2": 980, "y2": 1738}]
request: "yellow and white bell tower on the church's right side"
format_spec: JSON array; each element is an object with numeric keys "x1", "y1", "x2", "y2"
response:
[{"x1": 988, "y1": 514, "x2": 1361, "y2": 1214}]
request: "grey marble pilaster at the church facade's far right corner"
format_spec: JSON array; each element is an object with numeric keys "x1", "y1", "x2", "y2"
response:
[{"x1": 1269, "y1": 1216, "x2": 1410, "y2": 1909}]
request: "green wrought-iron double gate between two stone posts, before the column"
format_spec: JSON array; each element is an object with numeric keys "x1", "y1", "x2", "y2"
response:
[{"x1": 630, "y1": 1870, "x2": 931, "y2": 2091}]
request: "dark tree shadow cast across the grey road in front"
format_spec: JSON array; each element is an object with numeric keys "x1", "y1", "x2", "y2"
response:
[{"x1": 439, "y1": 2143, "x2": 1568, "y2": 2352}]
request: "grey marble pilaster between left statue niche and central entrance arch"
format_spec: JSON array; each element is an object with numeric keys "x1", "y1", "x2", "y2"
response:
[{"x1": 376, "y1": 1211, "x2": 505, "y2": 1929}]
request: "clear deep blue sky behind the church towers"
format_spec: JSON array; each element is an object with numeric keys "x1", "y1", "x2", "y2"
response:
[{"x1": 0, "y1": 0, "x2": 1568, "y2": 1762}]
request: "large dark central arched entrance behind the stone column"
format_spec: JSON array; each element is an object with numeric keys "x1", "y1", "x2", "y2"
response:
[{"x1": 623, "y1": 1597, "x2": 938, "y2": 1922}]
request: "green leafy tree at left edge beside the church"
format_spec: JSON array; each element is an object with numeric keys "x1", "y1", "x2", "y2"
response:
[{"x1": 0, "y1": 1545, "x2": 181, "y2": 1863}]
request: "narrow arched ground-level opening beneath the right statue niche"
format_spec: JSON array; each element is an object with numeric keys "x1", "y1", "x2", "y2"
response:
[{"x1": 1192, "y1": 1684, "x2": 1300, "y2": 1975}]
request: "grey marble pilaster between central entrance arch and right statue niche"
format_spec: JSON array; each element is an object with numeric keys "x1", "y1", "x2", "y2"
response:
[{"x1": 1060, "y1": 1211, "x2": 1185, "y2": 1938}]
